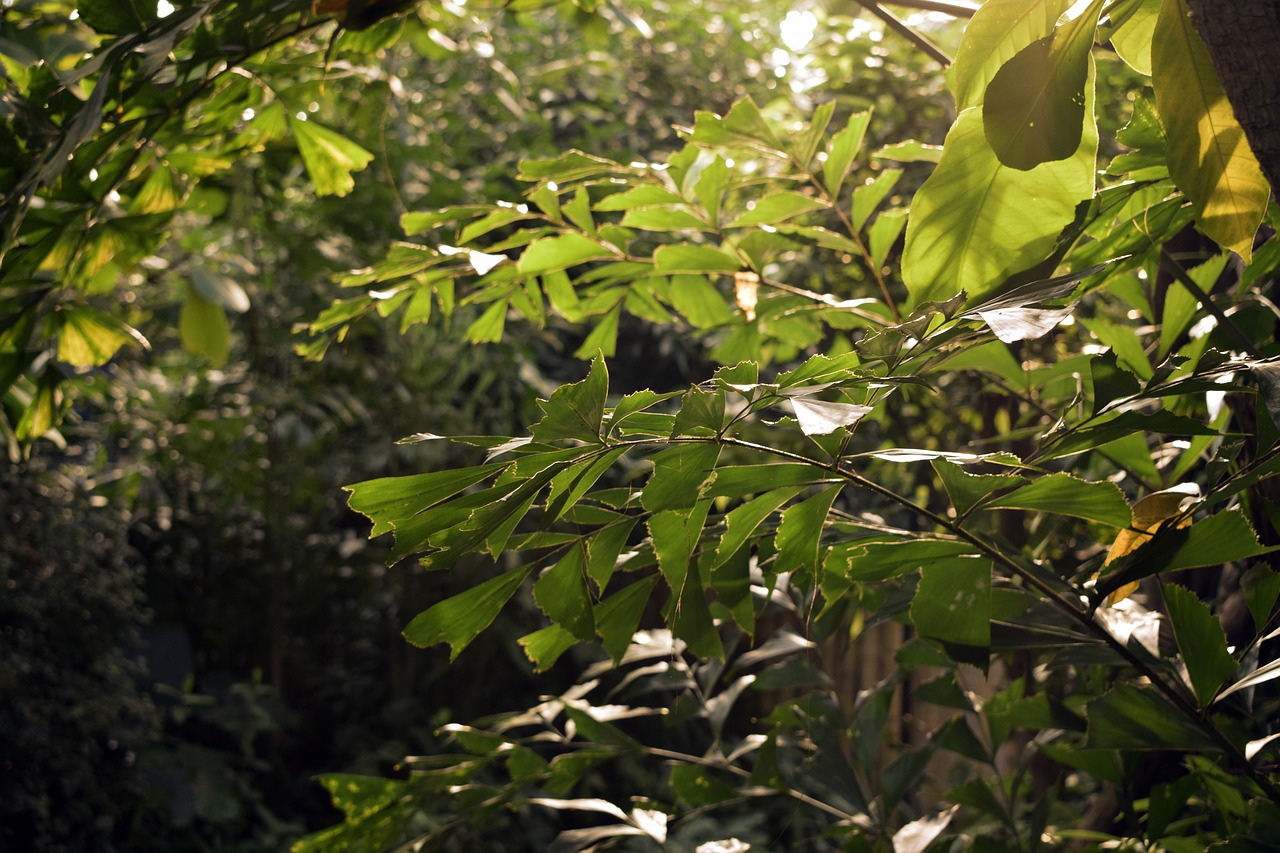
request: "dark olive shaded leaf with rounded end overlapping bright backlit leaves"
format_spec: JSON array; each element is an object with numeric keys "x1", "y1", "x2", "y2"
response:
[{"x1": 982, "y1": 0, "x2": 1102, "y2": 169}]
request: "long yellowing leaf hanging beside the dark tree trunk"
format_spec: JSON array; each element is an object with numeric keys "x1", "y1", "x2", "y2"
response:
[{"x1": 1151, "y1": 0, "x2": 1271, "y2": 261}]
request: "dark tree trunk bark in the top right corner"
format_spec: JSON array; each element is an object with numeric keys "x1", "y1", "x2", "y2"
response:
[{"x1": 1187, "y1": 0, "x2": 1280, "y2": 195}]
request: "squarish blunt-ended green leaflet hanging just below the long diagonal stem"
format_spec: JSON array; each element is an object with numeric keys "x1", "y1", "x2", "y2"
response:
[{"x1": 911, "y1": 557, "x2": 991, "y2": 648}]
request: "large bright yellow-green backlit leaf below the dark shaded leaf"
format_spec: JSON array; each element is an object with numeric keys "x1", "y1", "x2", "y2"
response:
[{"x1": 902, "y1": 101, "x2": 1098, "y2": 305}]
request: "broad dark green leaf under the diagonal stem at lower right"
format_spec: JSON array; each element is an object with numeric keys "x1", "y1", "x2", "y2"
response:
[{"x1": 1084, "y1": 684, "x2": 1217, "y2": 751}]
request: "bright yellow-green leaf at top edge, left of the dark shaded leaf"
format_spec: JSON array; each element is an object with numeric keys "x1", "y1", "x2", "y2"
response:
[{"x1": 950, "y1": 0, "x2": 1071, "y2": 110}]
